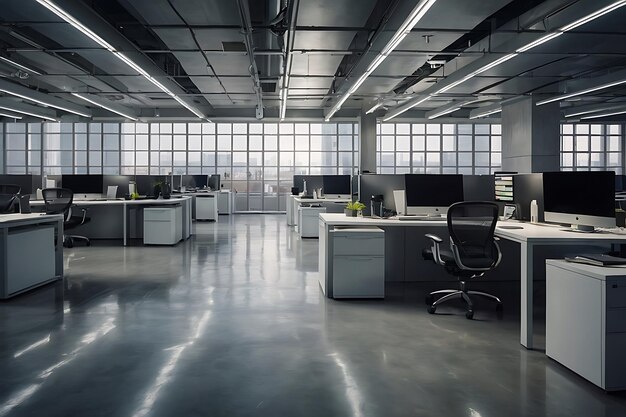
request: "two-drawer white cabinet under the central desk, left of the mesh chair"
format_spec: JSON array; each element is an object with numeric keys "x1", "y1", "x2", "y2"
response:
[{"x1": 330, "y1": 228, "x2": 385, "y2": 298}]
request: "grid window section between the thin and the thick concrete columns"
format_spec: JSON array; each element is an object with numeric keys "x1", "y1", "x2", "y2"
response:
[{"x1": 376, "y1": 123, "x2": 502, "y2": 174}]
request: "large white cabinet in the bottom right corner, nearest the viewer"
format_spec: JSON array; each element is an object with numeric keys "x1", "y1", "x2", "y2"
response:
[{"x1": 546, "y1": 260, "x2": 626, "y2": 391}]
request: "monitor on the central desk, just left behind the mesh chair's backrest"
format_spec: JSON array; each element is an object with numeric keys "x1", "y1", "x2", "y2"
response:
[{"x1": 404, "y1": 174, "x2": 463, "y2": 215}]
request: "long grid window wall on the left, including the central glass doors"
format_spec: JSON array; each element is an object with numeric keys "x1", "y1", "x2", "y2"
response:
[{"x1": 0, "y1": 123, "x2": 359, "y2": 211}]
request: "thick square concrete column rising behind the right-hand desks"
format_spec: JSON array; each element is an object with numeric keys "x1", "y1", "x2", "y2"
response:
[{"x1": 502, "y1": 97, "x2": 561, "y2": 173}]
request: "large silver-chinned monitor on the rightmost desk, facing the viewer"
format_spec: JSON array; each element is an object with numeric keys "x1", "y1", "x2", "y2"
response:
[{"x1": 543, "y1": 171, "x2": 615, "y2": 232}]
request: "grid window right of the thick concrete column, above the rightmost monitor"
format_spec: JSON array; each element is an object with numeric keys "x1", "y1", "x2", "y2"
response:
[{"x1": 561, "y1": 123, "x2": 624, "y2": 175}]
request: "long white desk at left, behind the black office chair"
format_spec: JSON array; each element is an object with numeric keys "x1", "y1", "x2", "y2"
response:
[{"x1": 30, "y1": 196, "x2": 192, "y2": 246}]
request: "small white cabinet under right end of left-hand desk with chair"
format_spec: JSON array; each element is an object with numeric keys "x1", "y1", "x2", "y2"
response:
[{"x1": 143, "y1": 206, "x2": 183, "y2": 245}]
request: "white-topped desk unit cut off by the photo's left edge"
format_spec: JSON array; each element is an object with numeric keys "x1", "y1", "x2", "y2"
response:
[{"x1": 0, "y1": 214, "x2": 63, "y2": 298}]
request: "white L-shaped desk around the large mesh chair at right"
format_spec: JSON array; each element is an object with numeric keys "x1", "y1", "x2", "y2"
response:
[{"x1": 319, "y1": 214, "x2": 626, "y2": 349}]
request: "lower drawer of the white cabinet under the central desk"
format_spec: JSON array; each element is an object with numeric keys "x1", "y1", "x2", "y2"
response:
[{"x1": 333, "y1": 256, "x2": 385, "y2": 298}]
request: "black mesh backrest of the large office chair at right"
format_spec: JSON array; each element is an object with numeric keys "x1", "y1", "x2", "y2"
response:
[{"x1": 448, "y1": 201, "x2": 500, "y2": 270}]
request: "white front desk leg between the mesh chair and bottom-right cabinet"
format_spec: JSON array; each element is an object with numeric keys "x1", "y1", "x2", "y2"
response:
[{"x1": 520, "y1": 243, "x2": 534, "y2": 349}]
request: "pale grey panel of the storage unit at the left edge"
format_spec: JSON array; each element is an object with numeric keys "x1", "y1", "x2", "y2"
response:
[{"x1": 0, "y1": 225, "x2": 57, "y2": 298}]
